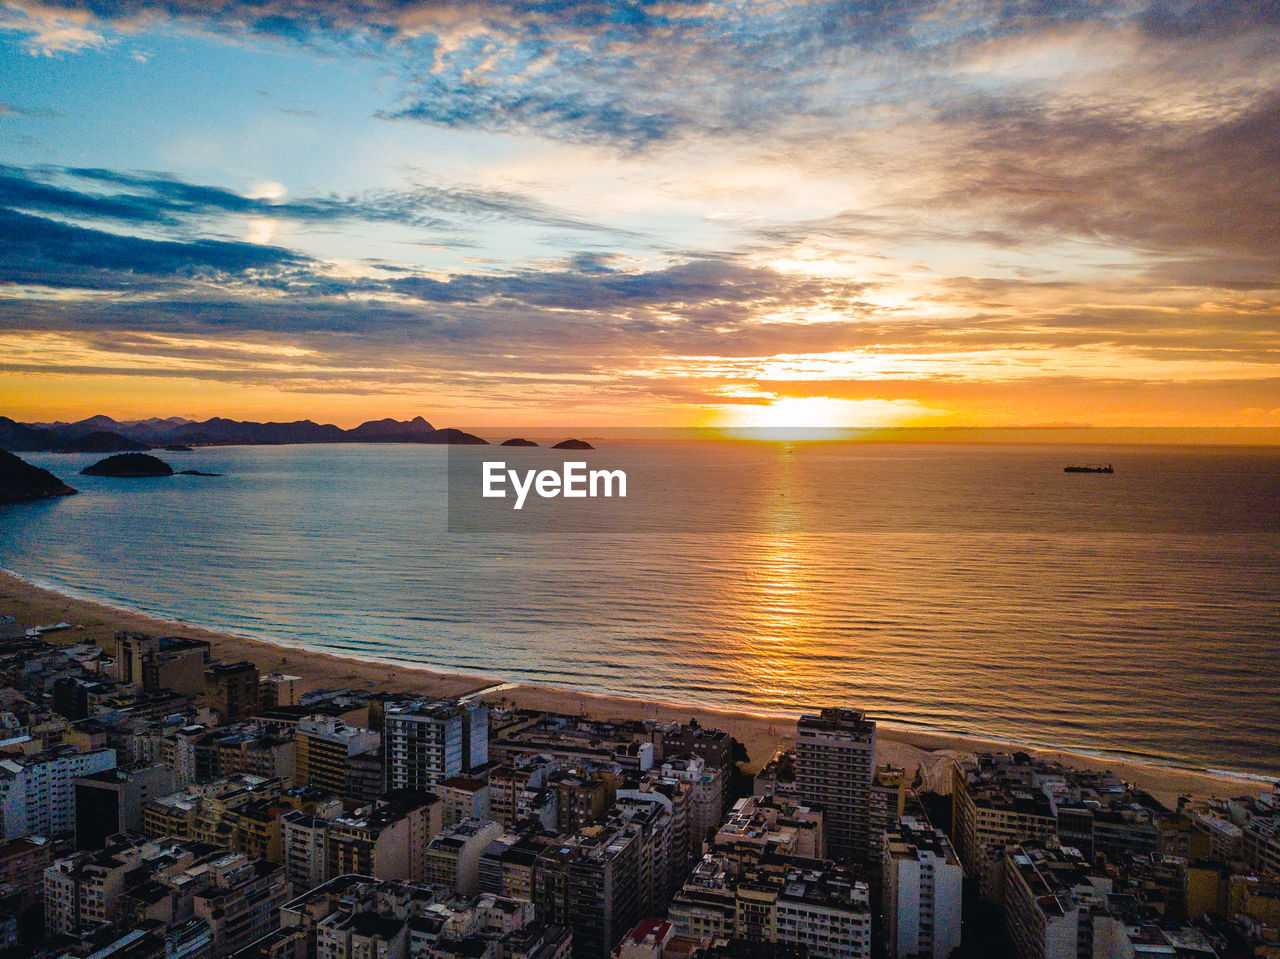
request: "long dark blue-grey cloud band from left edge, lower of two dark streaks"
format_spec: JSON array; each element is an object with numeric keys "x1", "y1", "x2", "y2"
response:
[{"x1": 0, "y1": 198, "x2": 872, "y2": 342}]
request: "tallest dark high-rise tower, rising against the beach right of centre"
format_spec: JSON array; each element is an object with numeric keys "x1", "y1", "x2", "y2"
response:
[{"x1": 795, "y1": 708, "x2": 876, "y2": 862}]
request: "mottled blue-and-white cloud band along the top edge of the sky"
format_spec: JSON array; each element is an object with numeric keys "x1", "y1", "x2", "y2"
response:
[{"x1": 12, "y1": 0, "x2": 1280, "y2": 167}]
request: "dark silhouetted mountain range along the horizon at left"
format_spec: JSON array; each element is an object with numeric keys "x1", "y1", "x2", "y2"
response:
[{"x1": 0, "y1": 416, "x2": 486, "y2": 453}]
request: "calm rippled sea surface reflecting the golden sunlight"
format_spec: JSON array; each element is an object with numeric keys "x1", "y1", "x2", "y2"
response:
[{"x1": 0, "y1": 442, "x2": 1280, "y2": 776}]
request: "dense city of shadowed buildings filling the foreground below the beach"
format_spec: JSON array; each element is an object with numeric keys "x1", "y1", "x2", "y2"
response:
[{"x1": 0, "y1": 616, "x2": 1280, "y2": 959}]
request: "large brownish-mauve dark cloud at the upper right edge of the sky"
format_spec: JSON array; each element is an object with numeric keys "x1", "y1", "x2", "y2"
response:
[{"x1": 933, "y1": 90, "x2": 1280, "y2": 286}]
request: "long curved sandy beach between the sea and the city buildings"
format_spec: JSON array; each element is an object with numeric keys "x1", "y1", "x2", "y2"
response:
[{"x1": 0, "y1": 570, "x2": 1267, "y2": 807}]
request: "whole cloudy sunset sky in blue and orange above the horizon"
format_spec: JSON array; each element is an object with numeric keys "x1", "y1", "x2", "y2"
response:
[{"x1": 0, "y1": 0, "x2": 1280, "y2": 428}]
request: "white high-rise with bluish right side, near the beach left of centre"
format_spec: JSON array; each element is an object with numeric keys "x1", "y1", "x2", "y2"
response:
[{"x1": 383, "y1": 699, "x2": 489, "y2": 791}]
